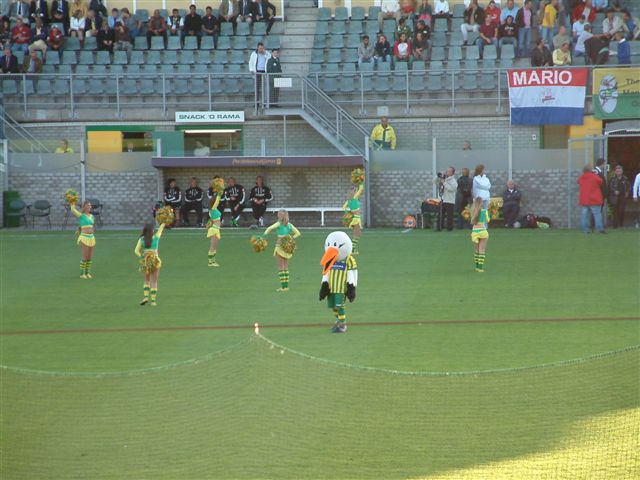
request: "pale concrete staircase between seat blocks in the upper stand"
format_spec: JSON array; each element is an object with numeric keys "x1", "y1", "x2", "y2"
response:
[{"x1": 280, "y1": 0, "x2": 318, "y2": 75}]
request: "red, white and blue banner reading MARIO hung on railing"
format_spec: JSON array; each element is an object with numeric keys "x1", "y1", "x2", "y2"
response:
[{"x1": 508, "y1": 68, "x2": 588, "y2": 125}]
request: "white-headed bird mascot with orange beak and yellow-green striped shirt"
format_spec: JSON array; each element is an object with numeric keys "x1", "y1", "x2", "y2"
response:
[{"x1": 320, "y1": 232, "x2": 358, "y2": 333}]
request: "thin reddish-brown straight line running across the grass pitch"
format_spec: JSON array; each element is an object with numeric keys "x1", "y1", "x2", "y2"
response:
[{"x1": 0, "y1": 317, "x2": 640, "y2": 336}]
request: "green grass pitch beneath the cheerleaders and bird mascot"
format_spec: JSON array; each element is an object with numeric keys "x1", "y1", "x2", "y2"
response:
[{"x1": 0, "y1": 229, "x2": 640, "y2": 479}]
